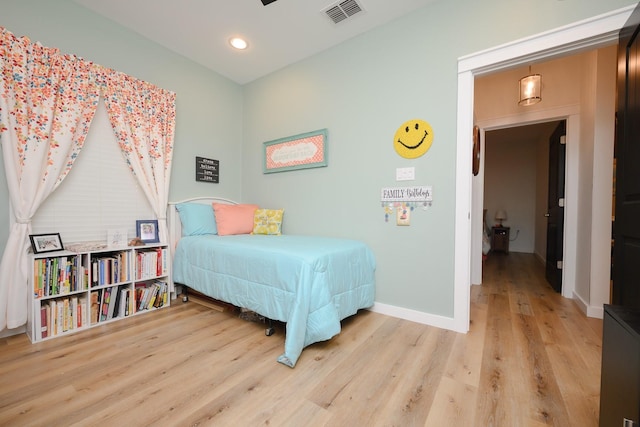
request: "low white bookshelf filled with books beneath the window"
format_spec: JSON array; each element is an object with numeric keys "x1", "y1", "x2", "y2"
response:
[{"x1": 27, "y1": 244, "x2": 171, "y2": 342}]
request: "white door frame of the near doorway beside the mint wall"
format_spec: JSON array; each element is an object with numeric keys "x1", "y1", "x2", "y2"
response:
[{"x1": 453, "y1": 5, "x2": 635, "y2": 332}]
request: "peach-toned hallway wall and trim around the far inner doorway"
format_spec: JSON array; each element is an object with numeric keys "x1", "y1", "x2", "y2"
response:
[{"x1": 472, "y1": 44, "x2": 617, "y2": 310}]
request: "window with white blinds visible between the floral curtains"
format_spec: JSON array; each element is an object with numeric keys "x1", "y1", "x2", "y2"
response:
[{"x1": 32, "y1": 100, "x2": 156, "y2": 244}]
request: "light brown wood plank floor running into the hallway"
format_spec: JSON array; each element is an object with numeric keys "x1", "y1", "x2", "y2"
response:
[{"x1": 0, "y1": 253, "x2": 602, "y2": 427}]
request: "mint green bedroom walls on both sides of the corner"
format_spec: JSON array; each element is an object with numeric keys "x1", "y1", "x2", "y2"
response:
[{"x1": 0, "y1": 0, "x2": 635, "y2": 316}]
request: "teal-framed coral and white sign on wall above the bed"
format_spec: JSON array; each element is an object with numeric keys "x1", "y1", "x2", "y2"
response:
[{"x1": 263, "y1": 129, "x2": 328, "y2": 173}]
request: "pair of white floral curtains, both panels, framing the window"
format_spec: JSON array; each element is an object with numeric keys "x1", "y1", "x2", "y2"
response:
[{"x1": 0, "y1": 27, "x2": 175, "y2": 330}]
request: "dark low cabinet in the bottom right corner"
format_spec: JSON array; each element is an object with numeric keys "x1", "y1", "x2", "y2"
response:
[{"x1": 600, "y1": 305, "x2": 640, "y2": 427}]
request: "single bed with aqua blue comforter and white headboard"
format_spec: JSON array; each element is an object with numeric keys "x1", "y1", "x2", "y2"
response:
[{"x1": 167, "y1": 198, "x2": 375, "y2": 368}]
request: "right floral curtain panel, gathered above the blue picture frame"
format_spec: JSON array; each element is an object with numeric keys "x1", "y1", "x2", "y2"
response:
[{"x1": 105, "y1": 71, "x2": 175, "y2": 249}]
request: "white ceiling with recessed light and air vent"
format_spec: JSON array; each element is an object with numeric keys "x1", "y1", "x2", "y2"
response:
[{"x1": 74, "y1": 0, "x2": 436, "y2": 84}]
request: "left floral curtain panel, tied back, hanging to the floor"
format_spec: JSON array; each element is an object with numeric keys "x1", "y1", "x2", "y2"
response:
[{"x1": 0, "y1": 27, "x2": 99, "y2": 330}]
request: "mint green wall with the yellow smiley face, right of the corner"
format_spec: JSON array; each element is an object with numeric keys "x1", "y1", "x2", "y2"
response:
[{"x1": 242, "y1": 0, "x2": 634, "y2": 317}]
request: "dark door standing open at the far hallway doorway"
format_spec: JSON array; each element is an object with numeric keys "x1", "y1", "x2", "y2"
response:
[{"x1": 545, "y1": 120, "x2": 567, "y2": 292}]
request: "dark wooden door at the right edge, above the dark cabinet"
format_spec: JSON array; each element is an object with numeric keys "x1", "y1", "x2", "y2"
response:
[{"x1": 612, "y1": 6, "x2": 640, "y2": 309}]
